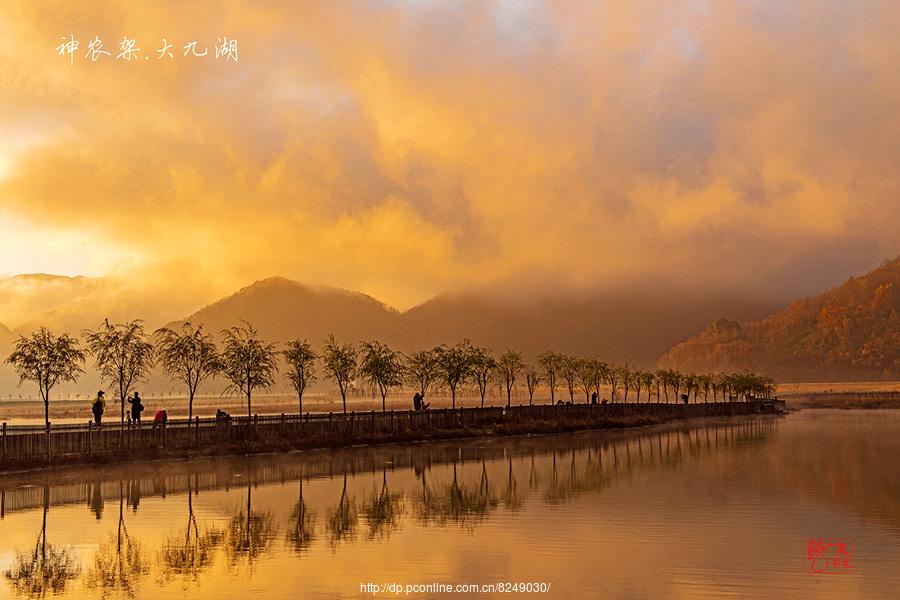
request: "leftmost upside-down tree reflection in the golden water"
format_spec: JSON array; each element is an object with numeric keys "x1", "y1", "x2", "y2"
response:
[{"x1": 4, "y1": 485, "x2": 81, "y2": 598}]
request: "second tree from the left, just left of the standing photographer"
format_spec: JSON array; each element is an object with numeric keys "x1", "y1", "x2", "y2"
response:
[{"x1": 84, "y1": 319, "x2": 153, "y2": 425}]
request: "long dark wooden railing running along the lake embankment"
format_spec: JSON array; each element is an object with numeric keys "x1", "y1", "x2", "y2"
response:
[{"x1": 0, "y1": 400, "x2": 777, "y2": 470}]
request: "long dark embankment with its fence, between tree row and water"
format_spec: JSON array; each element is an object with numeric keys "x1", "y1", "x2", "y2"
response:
[{"x1": 0, "y1": 400, "x2": 783, "y2": 472}]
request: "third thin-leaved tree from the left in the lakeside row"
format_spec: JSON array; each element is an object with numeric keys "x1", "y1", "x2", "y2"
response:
[{"x1": 155, "y1": 323, "x2": 222, "y2": 419}]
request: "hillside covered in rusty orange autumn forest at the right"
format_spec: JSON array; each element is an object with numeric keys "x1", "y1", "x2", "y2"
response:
[{"x1": 660, "y1": 258, "x2": 900, "y2": 381}]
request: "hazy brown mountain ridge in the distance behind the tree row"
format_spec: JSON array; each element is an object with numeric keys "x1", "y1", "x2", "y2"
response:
[{"x1": 172, "y1": 277, "x2": 773, "y2": 366}]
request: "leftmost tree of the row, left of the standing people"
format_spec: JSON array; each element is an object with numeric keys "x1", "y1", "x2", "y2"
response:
[{"x1": 6, "y1": 327, "x2": 84, "y2": 427}]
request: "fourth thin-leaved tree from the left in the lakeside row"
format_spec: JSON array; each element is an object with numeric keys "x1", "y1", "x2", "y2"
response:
[{"x1": 222, "y1": 321, "x2": 278, "y2": 419}]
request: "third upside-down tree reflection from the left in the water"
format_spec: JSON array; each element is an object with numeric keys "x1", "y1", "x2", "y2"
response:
[{"x1": 159, "y1": 478, "x2": 224, "y2": 581}]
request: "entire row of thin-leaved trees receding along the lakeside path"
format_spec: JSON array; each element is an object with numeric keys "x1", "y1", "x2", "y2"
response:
[{"x1": 6, "y1": 321, "x2": 775, "y2": 424}]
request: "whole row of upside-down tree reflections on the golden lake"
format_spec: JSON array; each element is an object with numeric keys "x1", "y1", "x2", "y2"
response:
[{"x1": 4, "y1": 420, "x2": 775, "y2": 598}]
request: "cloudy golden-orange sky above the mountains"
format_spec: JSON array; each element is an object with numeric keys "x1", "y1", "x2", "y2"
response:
[{"x1": 0, "y1": 0, "x2": 900, "y2": 308}]
